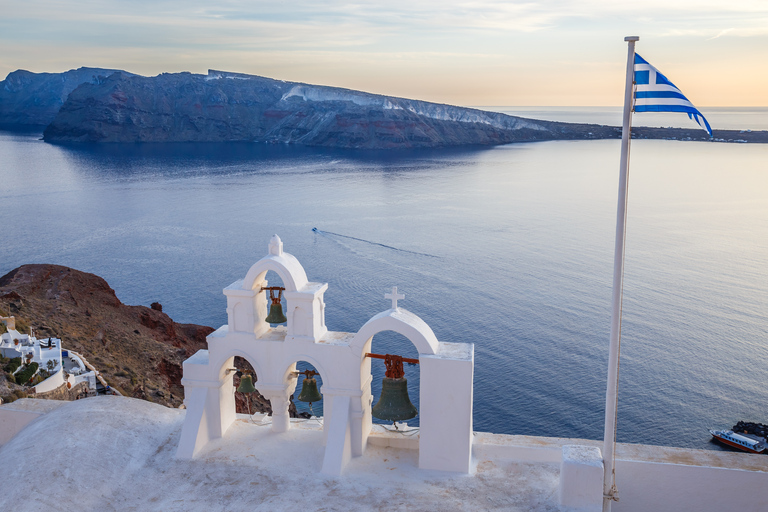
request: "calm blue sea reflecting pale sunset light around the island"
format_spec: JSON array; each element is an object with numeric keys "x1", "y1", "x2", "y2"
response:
[{"x1": 0, "y1": 107, "x2": 768, "y2": 450}]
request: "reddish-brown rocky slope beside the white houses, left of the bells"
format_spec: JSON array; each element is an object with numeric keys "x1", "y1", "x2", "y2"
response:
[{"x1": 0, "y1": 265, "x2": 213, "y2": 407}]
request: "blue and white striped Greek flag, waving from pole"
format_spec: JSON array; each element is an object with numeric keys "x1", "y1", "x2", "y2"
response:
[{"x1": 634, "y1": 54, "x2": 712, "y2": 137}]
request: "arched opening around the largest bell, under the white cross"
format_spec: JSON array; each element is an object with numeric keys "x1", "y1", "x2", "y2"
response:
[{"x1": 364, "y1": 330, "x2": 421, "y2": 428}]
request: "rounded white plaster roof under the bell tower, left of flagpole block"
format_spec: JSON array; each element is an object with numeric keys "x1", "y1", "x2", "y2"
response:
[{"x1": 0, "y1": 396, "x2": 559, "y2": 512}]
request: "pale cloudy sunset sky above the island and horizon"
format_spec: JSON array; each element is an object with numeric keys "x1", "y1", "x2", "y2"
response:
[{"x1": 0, "y1": 0, "x2": 768, "y2": 107}]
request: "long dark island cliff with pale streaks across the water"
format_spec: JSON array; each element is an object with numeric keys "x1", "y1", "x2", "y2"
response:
[{"x1": 44, "y1": 71, "x2": 618, "y2": 149}]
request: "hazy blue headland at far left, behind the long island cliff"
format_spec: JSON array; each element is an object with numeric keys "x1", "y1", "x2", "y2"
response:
[{"x1": 0, "y1": 68, "x2": 129, "y2": 127}]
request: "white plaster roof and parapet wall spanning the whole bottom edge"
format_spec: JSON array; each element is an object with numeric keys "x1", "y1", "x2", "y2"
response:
[{"x1": 0, "y1": 396, "x2": 768, "y2": 512}]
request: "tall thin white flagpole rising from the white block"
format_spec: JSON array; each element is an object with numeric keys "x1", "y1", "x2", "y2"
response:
[{"x1": 603, "y1": 36, "x2": 640, "y2": 512}]
